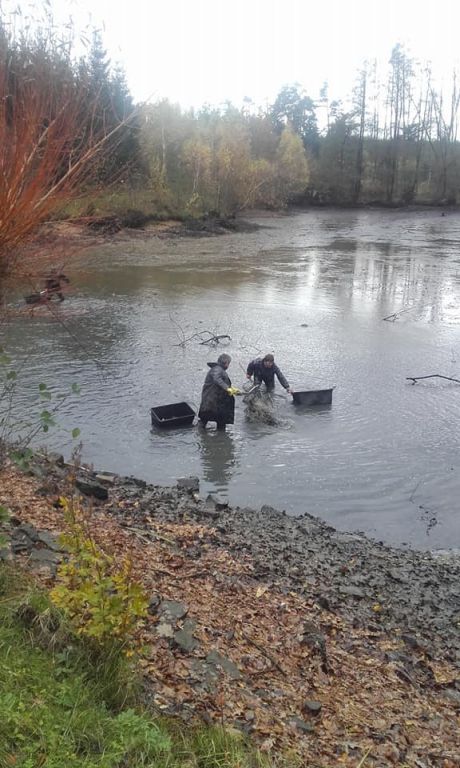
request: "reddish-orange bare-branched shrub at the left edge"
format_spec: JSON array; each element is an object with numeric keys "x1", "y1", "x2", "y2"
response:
[{"x1": 0, "y1": 19, "x2": 129, "y2": 299}]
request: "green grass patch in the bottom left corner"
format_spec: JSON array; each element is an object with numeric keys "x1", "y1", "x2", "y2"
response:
[{"x1": 0, "y1": 564, "x2": 269, "y2": 768}]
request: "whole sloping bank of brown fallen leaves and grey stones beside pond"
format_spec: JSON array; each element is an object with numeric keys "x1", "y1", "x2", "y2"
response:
[{"x1": 0, "y1": 457, "x2": 460, "y2": 768}]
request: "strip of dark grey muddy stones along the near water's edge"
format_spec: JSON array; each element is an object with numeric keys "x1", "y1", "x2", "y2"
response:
[{"x1": 108, "y1": 478, "x2": 460, "y2": 663}]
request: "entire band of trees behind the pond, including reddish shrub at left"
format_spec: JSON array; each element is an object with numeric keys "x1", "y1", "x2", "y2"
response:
[{"x1": 0, "y1": 3, "x2": 460, "y2": 280}]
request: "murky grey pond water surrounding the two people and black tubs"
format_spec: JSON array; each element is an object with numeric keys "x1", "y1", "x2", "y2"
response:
[{"x1": 2, "y1": 210, "x2": 460, "y2": 548}]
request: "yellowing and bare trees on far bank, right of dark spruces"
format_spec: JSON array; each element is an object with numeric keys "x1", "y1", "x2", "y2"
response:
[{"x1": 140, "y1": 45, "x2": 460, "y2": 213}]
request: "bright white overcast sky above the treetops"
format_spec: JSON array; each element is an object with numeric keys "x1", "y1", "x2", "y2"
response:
[{"x1": 8, "y1": 0, "x2": 460, "y2": 107}]
